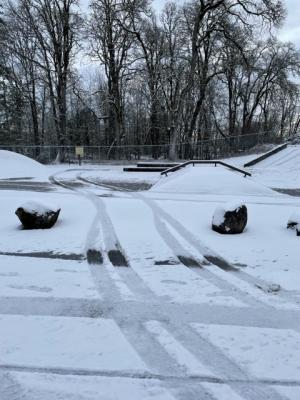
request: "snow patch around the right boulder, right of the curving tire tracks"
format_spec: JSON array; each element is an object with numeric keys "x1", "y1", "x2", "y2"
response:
[{"x1": 157, "y1": 196, "x2": 300, "y2": 290}]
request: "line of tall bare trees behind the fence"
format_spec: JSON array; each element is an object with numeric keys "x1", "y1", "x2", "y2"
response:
[{"x1": 0, "y1": 0, "x2": 300, "y2": 158}]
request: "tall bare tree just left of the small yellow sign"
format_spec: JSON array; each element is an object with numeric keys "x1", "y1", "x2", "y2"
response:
[{"x1": 5, "y1": 0, "x2": 81, "y2": 157}]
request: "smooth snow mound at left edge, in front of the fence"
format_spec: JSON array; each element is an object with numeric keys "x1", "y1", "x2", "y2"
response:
[{"x1": 0, "y1": 150, "x2": 47, "y2": 180}]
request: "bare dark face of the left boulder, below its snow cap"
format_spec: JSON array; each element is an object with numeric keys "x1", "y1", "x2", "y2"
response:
[{"x1": 15, "y1": 207, "x2": 60, "y2": 229}]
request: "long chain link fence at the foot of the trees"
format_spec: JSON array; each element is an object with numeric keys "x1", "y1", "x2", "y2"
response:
[{"x1": 0, "y1": 132, "x2": 283, "y2": 164}]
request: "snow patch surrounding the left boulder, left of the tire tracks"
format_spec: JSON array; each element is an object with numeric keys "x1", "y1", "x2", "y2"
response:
[{"x1": 0, "y1": 190, "x2": 95, "y2": 254}]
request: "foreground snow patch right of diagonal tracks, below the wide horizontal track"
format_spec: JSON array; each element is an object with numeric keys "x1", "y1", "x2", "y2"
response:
[{"x1": 192, "y1": 323, "x2": 300, "y2": 381}]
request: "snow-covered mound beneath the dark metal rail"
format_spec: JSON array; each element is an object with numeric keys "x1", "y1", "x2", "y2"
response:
[{"x1": 150, "y1": 165, "x2": 279, "y2": 196}]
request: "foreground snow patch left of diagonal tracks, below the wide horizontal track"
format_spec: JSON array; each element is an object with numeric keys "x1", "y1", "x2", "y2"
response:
[{"x1": 0, "y1": 315, "x2": 148, "y2": 373}]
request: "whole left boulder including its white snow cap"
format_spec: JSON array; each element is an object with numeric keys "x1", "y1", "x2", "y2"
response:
[{"x1": 15, "y1": 201, "x2": 60, "y2": 229}]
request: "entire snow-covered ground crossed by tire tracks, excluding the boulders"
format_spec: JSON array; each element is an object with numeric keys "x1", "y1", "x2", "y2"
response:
[{"x1": 0, "y1": 146, "x2": 300, "y2": 400}]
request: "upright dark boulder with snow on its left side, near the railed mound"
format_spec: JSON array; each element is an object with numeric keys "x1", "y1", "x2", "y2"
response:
[{"x1": 212, "y1": 203, "x2": 248, "y2": 234}]
